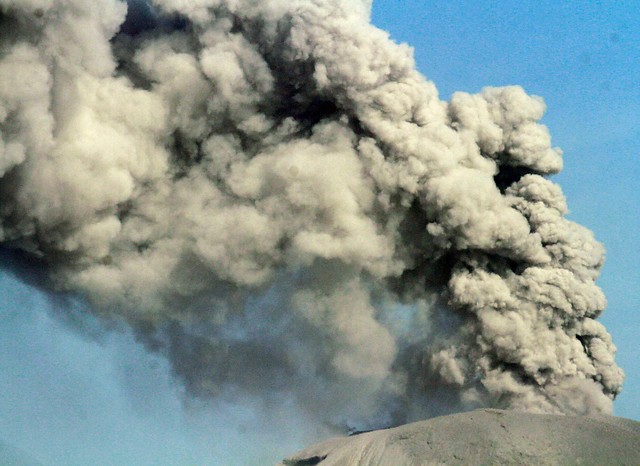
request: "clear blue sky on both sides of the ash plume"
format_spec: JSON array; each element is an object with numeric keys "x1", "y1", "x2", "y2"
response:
[{"x1": 0, "y1": 0, "x2": 640, "y2": 465}]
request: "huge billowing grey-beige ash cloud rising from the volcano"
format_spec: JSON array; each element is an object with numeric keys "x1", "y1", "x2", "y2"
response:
[{"x1": 0, "y1": 0, "x2": 623, "y2": 430}]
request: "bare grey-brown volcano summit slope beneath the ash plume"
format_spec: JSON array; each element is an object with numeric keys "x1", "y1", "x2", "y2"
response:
[{"x1": 280, "y1": 409, "x2": 640, "y2": 466}]
